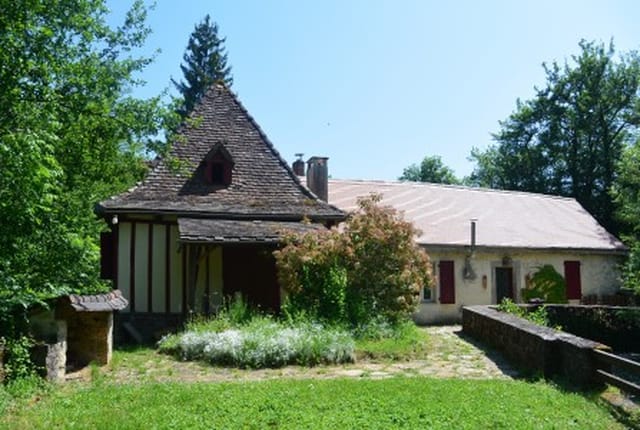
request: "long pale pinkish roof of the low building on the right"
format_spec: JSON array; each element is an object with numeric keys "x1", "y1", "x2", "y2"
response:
[{"x1": 329, "y1": 179, "x2": 626, "y2": 253}]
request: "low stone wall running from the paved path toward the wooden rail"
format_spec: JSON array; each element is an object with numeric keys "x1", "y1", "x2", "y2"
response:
[{"x1": 462, "y1": 306, "x2": 610, "y2": 386}]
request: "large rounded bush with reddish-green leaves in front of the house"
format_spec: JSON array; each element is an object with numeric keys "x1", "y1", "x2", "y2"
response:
[{"x1": 274, "y1": 195, "x2": 432, "y2": 326}]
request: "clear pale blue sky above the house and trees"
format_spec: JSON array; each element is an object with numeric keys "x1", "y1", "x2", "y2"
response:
[{"x1": 108, "y1": 0, "x2": 640, "y2": 180}]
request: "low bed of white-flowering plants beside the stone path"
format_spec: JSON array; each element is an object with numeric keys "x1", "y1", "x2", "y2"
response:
[{"x1": 159, "y1": 317, "x2": 354, "y2": 368}]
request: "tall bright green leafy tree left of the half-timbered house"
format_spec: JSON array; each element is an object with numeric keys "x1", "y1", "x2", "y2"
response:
[{"x1": 0, "y1": 0, "x2": 169, "y2": 333}]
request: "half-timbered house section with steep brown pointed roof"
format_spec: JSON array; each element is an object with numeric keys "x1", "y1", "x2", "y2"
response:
[{"x1": 96, "y1": 85, "x2": 345, "y2": 340}]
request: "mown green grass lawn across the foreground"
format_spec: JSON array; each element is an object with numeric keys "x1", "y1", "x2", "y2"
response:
[{"x1": 0, "y1": 377, "x2": 623, "y2": 429}]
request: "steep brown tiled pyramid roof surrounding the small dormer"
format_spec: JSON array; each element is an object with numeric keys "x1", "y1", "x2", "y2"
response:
[{"x1": 97, "y1": 85, "x2": 344, "y2": 220}]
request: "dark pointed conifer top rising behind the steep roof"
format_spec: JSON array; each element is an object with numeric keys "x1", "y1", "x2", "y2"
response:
[{"x1": 171, "y1": 15, "x2": 233, "y2": 117}]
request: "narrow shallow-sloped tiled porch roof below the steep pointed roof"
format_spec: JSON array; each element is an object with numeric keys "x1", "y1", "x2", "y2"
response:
[{"x1": 178, "y1": 218, "x2": 324, "y2": 243}]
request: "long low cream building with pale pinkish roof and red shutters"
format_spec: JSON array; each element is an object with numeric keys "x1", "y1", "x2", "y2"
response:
[{"x1": 318, "y1": 179, "x2": 627, "y2": 324}]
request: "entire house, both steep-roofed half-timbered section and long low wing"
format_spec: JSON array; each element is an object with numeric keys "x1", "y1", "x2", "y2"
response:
[{"x1": 96, "y1": 85, "x2": 626, "y2": 332}]
